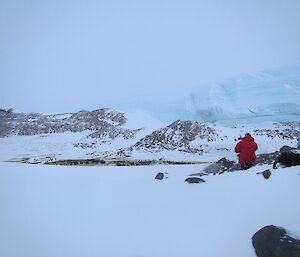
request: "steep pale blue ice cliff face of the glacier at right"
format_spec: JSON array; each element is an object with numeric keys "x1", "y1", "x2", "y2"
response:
[{"x1": 185, "y1": 65, "x2": 300, "y2": 122}]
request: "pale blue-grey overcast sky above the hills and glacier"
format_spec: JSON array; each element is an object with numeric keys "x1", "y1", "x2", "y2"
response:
[{"x1": 0, "y1": 0, "x2": 300, "y2": 112}]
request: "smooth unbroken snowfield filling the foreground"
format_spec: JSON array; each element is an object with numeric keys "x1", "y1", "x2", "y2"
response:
[{"x1": 0, "y1": 162, "x2": 300, "y2": 257}]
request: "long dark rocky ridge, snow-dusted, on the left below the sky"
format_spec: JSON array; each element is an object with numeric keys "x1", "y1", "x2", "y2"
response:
[{"x1": 0, "y1": 109, "x2": 136, "y2": 139}]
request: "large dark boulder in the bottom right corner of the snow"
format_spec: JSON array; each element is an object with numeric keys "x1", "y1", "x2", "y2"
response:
[{"x1": 252, "y1": 225, "x2": 300, "y2": 257}]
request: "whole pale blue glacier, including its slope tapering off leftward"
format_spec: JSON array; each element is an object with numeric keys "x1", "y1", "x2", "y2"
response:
[{"x1": 110, "y1": 64, "x2": 300, "y2": 125}]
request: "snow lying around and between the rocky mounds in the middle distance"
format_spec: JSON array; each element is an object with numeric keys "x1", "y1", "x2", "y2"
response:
[{"x1": 0, "y1": 118, "x2": 297, "y2": 162}]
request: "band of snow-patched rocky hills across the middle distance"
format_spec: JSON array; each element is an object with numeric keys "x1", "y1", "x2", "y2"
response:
[{"x1": 0, "y1": 106, "x2": 300, "y2": 162}]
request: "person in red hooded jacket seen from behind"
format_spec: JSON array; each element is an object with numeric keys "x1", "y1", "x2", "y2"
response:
[{"x1": 234, "y1": 133, "x2": 257, "y2": 170}]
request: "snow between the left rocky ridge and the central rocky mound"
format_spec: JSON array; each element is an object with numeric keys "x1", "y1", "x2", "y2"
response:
[{"x1": 0, "y1": 112, "x2": 167, "y2": 161}]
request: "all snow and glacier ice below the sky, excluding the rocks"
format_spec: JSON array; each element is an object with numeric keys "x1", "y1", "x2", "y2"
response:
[{"x1": 0, "y1": 63, "x2": 300, "y2": 254}]
